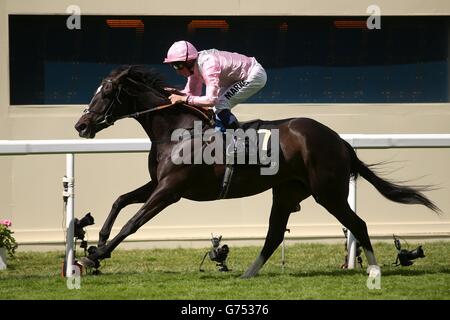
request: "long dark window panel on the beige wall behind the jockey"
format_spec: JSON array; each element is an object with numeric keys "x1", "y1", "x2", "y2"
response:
[{"x1": 9, "y1": 15, "x2": 450, "y2": 105}]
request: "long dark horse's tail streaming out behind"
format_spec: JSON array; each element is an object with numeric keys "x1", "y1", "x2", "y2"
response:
[{"x1": 344, "y1": 140, "x2": 441, "y2": 213}]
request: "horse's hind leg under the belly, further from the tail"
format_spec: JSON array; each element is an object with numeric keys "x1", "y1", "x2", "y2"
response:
[{"x1": 242, "y1": 182, "x2": 309, "y2": 278}]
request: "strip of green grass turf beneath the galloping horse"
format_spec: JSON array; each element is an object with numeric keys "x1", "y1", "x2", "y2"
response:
[{"x1": 0, "y1": 242, "x2": 450, "y2": 300}]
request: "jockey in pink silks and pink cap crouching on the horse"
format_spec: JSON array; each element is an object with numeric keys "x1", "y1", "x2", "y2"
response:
[{"x1": 164, "y1": 41, "x2": 267, "y2": 132}]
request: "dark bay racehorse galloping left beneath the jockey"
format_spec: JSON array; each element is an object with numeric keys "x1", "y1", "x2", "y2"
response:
[{"x1": 75, "y1": 66, "x2": 439, "y2": 277}]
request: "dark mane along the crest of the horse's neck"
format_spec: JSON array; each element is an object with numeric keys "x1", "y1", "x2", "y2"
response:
[{"x1": 109, "y1": 65, "x2": 168, "y2": 97}]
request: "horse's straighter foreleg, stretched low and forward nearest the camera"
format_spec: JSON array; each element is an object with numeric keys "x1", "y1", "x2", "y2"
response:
[{"x1": 80, "y1": 184, "x2": 180, "y2": 267}]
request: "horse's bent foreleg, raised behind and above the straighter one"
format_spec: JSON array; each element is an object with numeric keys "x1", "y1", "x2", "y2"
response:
[{"x1": 98, "y1": 180, "x2": 157, "y2": 247}]
